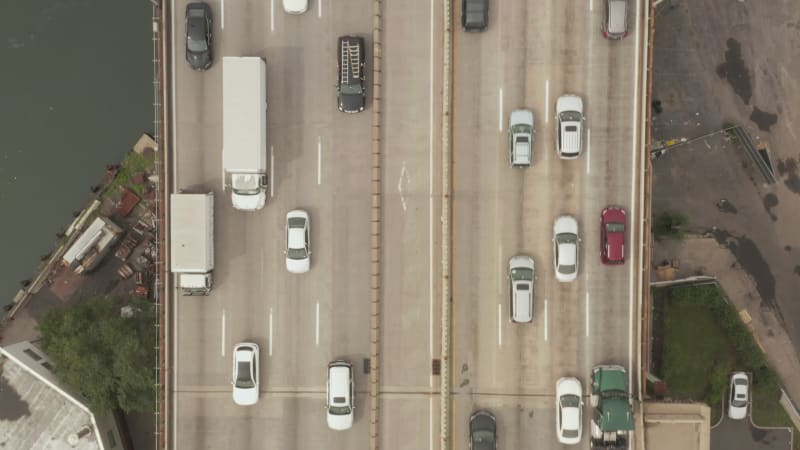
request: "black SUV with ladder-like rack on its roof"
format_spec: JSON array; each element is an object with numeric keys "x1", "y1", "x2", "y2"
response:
[{"x1": 336, "y1": 36, "x2": 367, "y2": 113}]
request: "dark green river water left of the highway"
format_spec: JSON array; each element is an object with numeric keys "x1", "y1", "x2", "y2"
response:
[{"x1": 0, "y1": 0, "x2": 153, "y2": 305}]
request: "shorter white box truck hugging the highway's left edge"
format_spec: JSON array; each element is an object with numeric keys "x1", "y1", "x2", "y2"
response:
[{"x1": 170, "y1": 192, "x2": 214, "y2": 295}]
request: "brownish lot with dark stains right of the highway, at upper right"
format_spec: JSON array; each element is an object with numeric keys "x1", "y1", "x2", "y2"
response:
[{"x1": 653, "y1": 0, "x2": 800, "y2": 349}]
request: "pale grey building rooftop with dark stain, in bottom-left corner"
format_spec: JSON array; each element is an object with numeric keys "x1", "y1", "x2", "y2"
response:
[{"x1": 0, "y1": 342, "x2": 102, "y2": 450}]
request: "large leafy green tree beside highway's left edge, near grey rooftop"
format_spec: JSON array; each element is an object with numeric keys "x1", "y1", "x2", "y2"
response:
[{"x1": 39, "y1": 296, "x2": 157, "y2": 414}]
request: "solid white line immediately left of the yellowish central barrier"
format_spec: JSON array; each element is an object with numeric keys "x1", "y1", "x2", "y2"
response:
[{"x1": 428, "y1": 0, "x2": 435, "y2": 358}]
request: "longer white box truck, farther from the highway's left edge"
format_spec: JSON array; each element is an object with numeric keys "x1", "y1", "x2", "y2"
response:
[{"x1": 222, "y1": 56, "x2": 267, "y2": 211}]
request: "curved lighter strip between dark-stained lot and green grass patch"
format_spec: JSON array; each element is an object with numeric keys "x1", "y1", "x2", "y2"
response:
[{"x1": 652, "y1": 236, "x2": 800, "y2": 429}]
